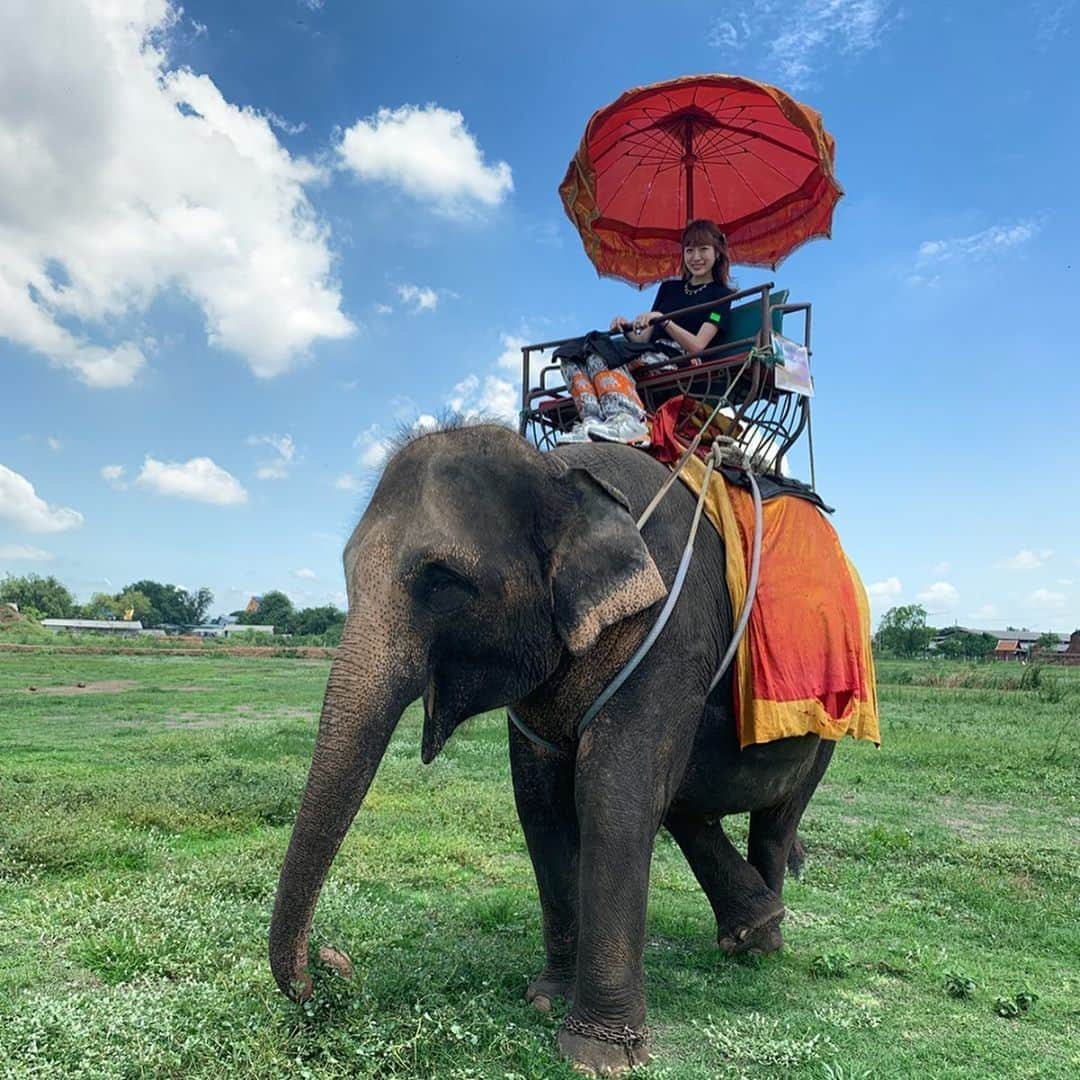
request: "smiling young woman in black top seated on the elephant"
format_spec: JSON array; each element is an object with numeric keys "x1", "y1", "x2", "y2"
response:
[{"x1": 558, "y1": 218, "x2": 734, "y2": 446}]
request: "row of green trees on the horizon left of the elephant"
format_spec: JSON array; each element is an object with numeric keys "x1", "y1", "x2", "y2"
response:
[{"x1": 0, "y1": 573, "x2": 345, "y2": 635}]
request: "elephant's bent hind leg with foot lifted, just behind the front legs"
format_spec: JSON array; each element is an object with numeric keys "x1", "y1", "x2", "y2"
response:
[{"x1": 664, "y1": 810, "x2": 784, "y2": 956}]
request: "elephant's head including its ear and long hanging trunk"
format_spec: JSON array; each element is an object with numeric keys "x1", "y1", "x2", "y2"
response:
[{"x1": 270, "y1": 426, "x2": 665, "y2": 998}]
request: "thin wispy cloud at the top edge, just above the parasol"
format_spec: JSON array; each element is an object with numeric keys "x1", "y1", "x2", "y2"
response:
[{"x1": 707, "y1": 0, "x2": 896, "y2": 90}]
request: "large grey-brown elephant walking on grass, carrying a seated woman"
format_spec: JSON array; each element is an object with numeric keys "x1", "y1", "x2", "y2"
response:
[{"x1": 269, "y1": 423, "x2": 835, "y2": 1072}]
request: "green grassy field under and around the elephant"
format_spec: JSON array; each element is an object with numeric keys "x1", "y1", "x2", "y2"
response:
[{"x1": 0, "y1": 653, "x2": 1080, "y2": 1080}]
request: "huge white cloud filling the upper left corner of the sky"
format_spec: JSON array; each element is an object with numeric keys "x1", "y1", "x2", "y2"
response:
[{"x1": 0, "y1": 0, "x2": 353, "y2": 388}]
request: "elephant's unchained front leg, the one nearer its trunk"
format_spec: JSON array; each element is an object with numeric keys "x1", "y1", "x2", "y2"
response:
[{"x1": 510, "y1": 725, "x2": 578, "y2": 1012}]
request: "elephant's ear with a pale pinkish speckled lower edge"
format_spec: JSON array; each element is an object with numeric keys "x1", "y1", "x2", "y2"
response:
[{"x1": 549, "y1": 468, "x2": 667, "y2": 657}]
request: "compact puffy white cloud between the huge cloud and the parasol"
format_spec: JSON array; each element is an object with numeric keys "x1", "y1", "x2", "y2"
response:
[{"x1": 338, "y1": 104, "x2": 514, "y2": 214}]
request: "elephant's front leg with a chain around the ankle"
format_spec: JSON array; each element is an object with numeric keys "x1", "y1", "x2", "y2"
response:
[{"x1": 558, "y1": 773, "x2": 657, "y2": 1074}]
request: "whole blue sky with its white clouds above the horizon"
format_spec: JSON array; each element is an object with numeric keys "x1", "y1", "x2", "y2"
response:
[{"x1": 0, "y1": 0, "x2": 1080, "y2": 632}]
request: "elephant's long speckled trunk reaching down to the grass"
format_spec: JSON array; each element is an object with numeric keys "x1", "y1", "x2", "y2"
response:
[{"x1": 270, "y1": 615, "x2": 421, "y2": 1001}]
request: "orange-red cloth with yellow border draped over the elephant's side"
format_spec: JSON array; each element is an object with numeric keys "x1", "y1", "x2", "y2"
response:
[{"x1": 679, "y1": 456, "x2": 881, "y2": 746}]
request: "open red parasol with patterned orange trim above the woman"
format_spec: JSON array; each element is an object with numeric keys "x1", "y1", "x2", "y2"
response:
[{"x1": 558, "y1": 75, "x2": 843, "y2": 285}]
